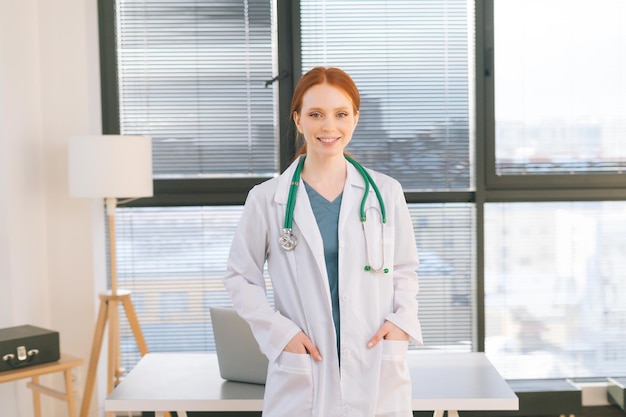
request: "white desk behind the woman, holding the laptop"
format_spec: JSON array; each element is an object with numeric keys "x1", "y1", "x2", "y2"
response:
[{"x1": 104, "y1": 352, "x2": 519, "y2": 417}]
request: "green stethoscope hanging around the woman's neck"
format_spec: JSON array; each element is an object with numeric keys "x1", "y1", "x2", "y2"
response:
[{"x1": 278, "y1": 155, "x2": 389, "y2": 274}]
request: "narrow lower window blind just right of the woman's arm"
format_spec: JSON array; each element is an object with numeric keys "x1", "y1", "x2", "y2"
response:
[{"x1": 409, "y1": 203, "x2": 475, "y2": 352}]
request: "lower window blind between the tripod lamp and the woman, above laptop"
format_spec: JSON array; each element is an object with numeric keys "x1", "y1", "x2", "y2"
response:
[{"x1": 116, "y1": 206, "x2": 252, "y2": 369}]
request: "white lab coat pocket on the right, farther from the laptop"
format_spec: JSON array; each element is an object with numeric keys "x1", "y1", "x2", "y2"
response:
[{"x1": 376, "y1": 340, "x2": 413, "y2": 417}]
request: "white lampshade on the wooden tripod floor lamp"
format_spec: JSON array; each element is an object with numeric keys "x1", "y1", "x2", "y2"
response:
[{"x1": 68, "y1": 135, "x2": 152, "y2": 198}]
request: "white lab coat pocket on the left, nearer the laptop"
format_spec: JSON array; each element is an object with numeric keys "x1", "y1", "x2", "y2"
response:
[{"x1": 263, "y1": 352, "x2": 313, "y2": 417}]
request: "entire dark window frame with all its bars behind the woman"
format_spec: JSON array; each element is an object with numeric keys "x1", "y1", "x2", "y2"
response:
[{"x1": 98, "y1": 0, "x2": 626, "y2": 380}]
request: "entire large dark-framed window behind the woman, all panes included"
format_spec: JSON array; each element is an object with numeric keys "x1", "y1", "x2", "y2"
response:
[{"x1": 101, "y1": 0, "x2": 626, "y2": 379}]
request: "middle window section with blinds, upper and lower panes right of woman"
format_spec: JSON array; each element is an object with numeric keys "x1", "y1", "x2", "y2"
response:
[{"x1": 300, "y1": 0, "x2": 475, "y2": 351}]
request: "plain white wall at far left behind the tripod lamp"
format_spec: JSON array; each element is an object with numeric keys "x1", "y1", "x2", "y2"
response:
[{"x1": 0, "y1": 0, "x2": 105, "y2": 417}]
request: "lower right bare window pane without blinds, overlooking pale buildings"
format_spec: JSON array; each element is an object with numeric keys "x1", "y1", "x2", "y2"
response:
[{"x1": 485, "y1": 201, "x2": 626, "y2": 379}]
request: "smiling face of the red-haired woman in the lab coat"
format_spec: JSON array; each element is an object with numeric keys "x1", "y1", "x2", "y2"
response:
[{"x1": 293, "y1": 83, "x2": 359, "y2": 158}]
